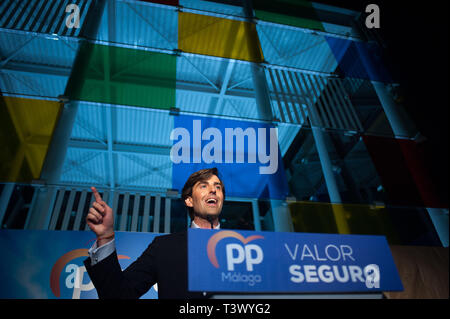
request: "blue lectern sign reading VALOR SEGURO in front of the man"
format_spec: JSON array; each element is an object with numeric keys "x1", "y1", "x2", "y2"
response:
[{"x1": 188, "y1": 229, "x2": 403, "y2": 293}]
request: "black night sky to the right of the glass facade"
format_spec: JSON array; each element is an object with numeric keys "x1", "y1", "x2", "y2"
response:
[{"x1": 315, "y1": 0, "x2": 449, "y2": 200}]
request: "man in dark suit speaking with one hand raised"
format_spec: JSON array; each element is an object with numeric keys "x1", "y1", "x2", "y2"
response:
[{"x1": 84, "y1": 168, "x2": 225, "y2": 299}]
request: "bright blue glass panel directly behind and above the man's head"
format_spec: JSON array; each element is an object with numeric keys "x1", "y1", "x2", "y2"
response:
[{"x1": 170, "y1": 115, "x2": 289, "y2": 199}]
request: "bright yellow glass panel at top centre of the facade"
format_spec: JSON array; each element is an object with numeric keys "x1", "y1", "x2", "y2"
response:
[{"x1": 178, "y1": 12, "x2": 264, "y2": 62}]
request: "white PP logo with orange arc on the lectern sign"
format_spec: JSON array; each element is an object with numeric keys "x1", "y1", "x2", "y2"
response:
[{"x1": 207, "y1": 230, "x2": 264, "y2": 271}]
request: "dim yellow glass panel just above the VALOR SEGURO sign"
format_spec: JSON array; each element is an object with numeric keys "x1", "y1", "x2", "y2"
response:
[{"x1": 289, "y1": 202, "x2": 400, "y2": 244}]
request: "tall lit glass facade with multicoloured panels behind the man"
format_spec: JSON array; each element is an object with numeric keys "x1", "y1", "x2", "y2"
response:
[{"x1": 0, "y1": 0, "x2": 448, "y2": 249}]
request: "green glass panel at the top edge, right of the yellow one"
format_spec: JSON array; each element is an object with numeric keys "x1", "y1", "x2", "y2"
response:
[{"x1": 253, "y1": 0, "x2": 325, "y2": 31}]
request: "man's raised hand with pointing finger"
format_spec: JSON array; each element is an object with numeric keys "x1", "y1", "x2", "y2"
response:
[{"x1": 86, "y1": 187, "x2": 114, "y2": 247}]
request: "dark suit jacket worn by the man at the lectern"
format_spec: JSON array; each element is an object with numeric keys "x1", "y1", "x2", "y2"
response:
[{"x1": 84, "y1": 231, "x2": 210, "y2": 299}]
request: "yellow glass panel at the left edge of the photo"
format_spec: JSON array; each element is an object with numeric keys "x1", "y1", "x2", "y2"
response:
[{"x1": 0, "y1": 96, "x2": 60, "y2": 182}]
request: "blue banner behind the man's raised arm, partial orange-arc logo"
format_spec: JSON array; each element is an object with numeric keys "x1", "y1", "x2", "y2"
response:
[{"x1": 0, "y1": 230, "x2": 159, "y2": 299}]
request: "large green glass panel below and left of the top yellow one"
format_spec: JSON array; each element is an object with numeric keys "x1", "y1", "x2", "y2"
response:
[{"x1": 66, "y1": 43, "x2": 176, "y2": 109}]
